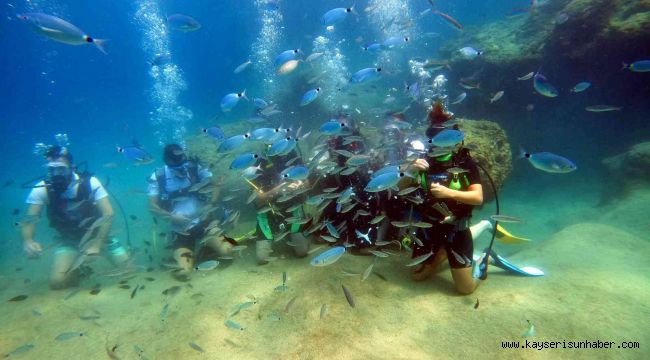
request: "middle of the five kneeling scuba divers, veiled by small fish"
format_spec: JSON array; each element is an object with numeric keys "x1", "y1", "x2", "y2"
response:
[{"x1": 247, "y1": 146, "x2": 310, "y2": 265}]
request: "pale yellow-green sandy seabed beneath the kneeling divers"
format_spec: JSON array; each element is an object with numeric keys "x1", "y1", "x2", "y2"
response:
[{"x1": 0, "y1": 190, "x2": 650, "y2": 359}]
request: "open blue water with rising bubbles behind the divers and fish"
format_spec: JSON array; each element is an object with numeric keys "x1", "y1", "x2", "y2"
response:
[{"x1": 0, "y1": 0, "x2": 650, "y2": 356}]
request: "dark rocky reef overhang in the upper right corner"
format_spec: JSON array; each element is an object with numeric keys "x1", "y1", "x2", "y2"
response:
[{"x1": 440, "y1": 0, "x2": 650, "y2": 112}]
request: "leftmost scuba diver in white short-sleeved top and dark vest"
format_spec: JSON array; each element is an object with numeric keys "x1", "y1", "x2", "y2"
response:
[{"x1": 21, "y1": 141, "x2": 129, "y2": 289}]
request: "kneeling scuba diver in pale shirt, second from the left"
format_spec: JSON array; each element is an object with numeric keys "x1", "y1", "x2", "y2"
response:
[{"x1": 148, "y1": 144, "x2": 235, "y2": 280}]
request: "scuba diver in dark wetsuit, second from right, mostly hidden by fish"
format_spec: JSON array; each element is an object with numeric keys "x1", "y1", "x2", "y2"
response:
[{"x1": 318, "y1": 114, "x2": 386, "y2": 252}]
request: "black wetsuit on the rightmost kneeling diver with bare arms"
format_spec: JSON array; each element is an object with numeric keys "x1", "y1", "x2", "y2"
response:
[{"x1": 413, "y1": 149, "x2": 481, "y2": 269}]
